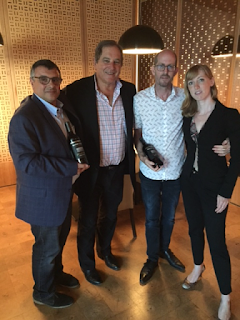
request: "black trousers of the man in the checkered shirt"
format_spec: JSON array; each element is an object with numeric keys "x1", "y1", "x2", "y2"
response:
[{"x1": 77, "y1": 163, "x2": 124, "y2": 271}]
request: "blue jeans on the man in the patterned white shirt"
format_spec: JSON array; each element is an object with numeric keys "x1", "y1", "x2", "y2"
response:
[{"x1": 139, "y1": 172, "x2": 180, "y2": 261}]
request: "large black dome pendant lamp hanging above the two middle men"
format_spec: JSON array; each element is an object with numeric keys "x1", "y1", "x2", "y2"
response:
[{"x1": 118, "y1": 25, "x2": 164, "y2": 54}]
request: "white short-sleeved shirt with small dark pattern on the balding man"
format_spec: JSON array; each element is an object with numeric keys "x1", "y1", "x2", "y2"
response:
[{"x1": 133, "y1": 85, "x2": 185, "y2": 180}]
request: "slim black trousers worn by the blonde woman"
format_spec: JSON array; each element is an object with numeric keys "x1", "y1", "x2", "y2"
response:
[{"x1": 181, "y1": 173, "x2": 232, "y2": 294}]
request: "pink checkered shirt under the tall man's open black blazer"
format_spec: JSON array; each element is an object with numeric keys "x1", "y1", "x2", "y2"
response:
[{"x1": 95, "y1": 75, "x2": 126, "y2": 167}]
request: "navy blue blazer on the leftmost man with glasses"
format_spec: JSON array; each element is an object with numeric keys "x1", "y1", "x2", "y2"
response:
[{"x1": 8, "y1": 95, "x2": 80, "y2": 226}]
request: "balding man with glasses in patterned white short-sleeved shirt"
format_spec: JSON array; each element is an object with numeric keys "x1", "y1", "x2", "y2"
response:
[{"x1": 133, "y1": 49, "x2": 228, "y2": 285}]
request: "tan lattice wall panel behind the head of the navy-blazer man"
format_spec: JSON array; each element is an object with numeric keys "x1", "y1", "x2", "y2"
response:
[{"x1": 8, "y1": 0, "x2": 83, "y2": 102}]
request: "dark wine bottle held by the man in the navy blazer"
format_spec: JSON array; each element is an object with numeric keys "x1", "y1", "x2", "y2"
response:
[{"x1": 65, "y1": 121, "x2": 88, "y2": 164}]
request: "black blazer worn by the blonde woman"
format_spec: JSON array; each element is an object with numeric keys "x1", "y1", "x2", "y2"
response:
[{"x1": 182, "y1": 100, "x2": 240, "y2": 198}]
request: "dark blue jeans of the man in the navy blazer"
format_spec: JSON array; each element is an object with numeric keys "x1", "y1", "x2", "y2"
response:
[{"x1": 31, "y1": 202, "x2": 72, "y2": 302}]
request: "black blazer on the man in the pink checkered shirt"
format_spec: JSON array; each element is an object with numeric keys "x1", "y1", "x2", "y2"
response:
[{"x1": 64, "y1": 76, "x2": 136, "y2": 195}]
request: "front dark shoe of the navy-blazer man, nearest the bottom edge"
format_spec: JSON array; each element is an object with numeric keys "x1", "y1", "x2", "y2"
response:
[{"x1": 33, "y1": 292, "x2": 74, "y2": 309}]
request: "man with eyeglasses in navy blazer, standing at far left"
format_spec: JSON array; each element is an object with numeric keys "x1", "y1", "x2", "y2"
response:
[{"x1": 8, "y1": 60, "x2": 89, "y2": 308}]
